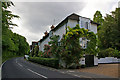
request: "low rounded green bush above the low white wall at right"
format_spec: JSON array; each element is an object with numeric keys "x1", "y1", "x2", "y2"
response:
[{"x1": 98, "y1": 48, "x2": 120, "y2": 58}]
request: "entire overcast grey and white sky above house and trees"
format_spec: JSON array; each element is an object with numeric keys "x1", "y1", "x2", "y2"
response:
[{"x1": 10, "y1": 0, "x2": 118, "y2": 44}]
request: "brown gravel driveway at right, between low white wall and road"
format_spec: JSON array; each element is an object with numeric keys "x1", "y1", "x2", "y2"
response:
[{"x1": 79, "y1": 64, "x2": 120, "y2": 78}]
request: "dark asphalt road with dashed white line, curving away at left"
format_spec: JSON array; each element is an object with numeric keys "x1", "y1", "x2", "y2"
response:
[{"x1": 2, "y1": 57, "x2": 82, "y2": 79}]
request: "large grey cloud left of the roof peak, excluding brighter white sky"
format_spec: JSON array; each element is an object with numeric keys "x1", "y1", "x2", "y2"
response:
[{"x1": 15, "y1": 2, "x2": 85, "y2": 34}]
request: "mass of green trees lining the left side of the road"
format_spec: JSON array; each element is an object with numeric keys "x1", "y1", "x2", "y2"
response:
[{"x1": 2, "y1": 1, "x2": 29, "y2": 61}]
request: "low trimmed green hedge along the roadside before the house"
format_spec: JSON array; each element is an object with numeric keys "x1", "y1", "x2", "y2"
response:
[{"x1": 28, "y1": 57, "x2": 59, "y2": 68}]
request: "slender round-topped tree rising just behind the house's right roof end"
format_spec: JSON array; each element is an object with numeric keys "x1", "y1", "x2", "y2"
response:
[{"x1": 93, "y1": 11, "x2": 104, "y2": 31}]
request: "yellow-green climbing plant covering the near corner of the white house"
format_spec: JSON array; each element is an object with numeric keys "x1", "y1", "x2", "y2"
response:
[{"x1": 61, "y1": 25, "x2": 97, "y2": 68}]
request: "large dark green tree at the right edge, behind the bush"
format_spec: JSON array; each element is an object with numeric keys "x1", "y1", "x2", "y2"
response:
[{"x1": 98, "y1": 8, "x2": 120, "y2": 50}]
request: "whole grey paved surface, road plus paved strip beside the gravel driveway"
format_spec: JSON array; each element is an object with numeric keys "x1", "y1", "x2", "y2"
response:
[{"x1": 2, "y1": 57, "x2": 119, "y2": 80}]
